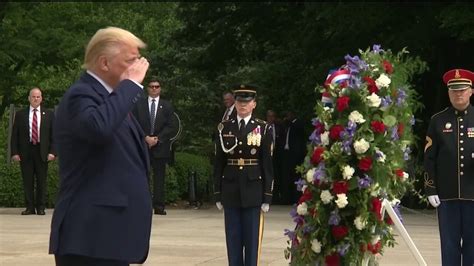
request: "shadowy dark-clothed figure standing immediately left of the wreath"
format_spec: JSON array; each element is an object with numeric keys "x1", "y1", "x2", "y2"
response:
[{"x1": 280, "y1": 111, "x2": 308, "y2": 204}]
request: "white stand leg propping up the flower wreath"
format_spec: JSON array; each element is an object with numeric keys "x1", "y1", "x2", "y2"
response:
[{"x1": 362, "y1": 199, "x2": 427, "y2": 266}]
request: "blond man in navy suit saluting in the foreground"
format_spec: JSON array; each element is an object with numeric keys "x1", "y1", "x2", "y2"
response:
[{"x1": 49, "y1": 27, "x2": 152, "y2": 266}]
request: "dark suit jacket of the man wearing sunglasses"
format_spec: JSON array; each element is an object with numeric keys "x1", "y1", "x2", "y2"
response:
[{"x1": 133, "y1": 95, "x2": 179, "y2": 158}]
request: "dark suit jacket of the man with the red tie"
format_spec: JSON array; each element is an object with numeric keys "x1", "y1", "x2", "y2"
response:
[{"x1": 11, "y1": 106, "x2": 56, "y2": 162}]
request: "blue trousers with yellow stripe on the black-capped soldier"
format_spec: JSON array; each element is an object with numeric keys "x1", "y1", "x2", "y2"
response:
[{"x1": 224, "y1": 207, "x2": 263, "y2": 266}]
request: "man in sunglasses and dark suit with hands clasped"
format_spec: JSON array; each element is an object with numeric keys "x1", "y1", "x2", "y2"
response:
[{"x1": 133, "y1": 77, "x2": 178, "y2": 215}]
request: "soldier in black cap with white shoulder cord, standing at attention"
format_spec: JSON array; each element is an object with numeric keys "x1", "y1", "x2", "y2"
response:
[{"x1": 214, "y1": 85, "x2": 273, "y2": 266}]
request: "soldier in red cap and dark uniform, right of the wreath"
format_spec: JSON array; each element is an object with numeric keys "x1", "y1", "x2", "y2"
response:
[{"x1": 424, "y1": 69, "x2": 474, "y2": 266}]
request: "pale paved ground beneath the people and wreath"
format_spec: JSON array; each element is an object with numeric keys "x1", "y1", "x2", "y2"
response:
[{"x1": 0, "y1": 206, "x2": 441, "y2": 266}]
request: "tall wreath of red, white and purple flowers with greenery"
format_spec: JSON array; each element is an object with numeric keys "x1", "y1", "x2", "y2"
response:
[{"x1": 285, "y1": 45, "x2": 423, "y2": 265}]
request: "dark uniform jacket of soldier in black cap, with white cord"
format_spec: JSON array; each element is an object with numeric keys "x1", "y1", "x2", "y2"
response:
[{"x1": 214, "y1": 116, "x2": 273, "y2": 208}]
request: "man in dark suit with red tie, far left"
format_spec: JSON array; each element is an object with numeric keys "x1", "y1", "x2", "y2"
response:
[{"x1": 11, "y1": 88, "x2": 56, "y2": 215}]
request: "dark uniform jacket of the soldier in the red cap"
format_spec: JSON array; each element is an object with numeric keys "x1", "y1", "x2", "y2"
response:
[{"x1": 424, "y1": 106, "x2": 474, "y2": 200}]
